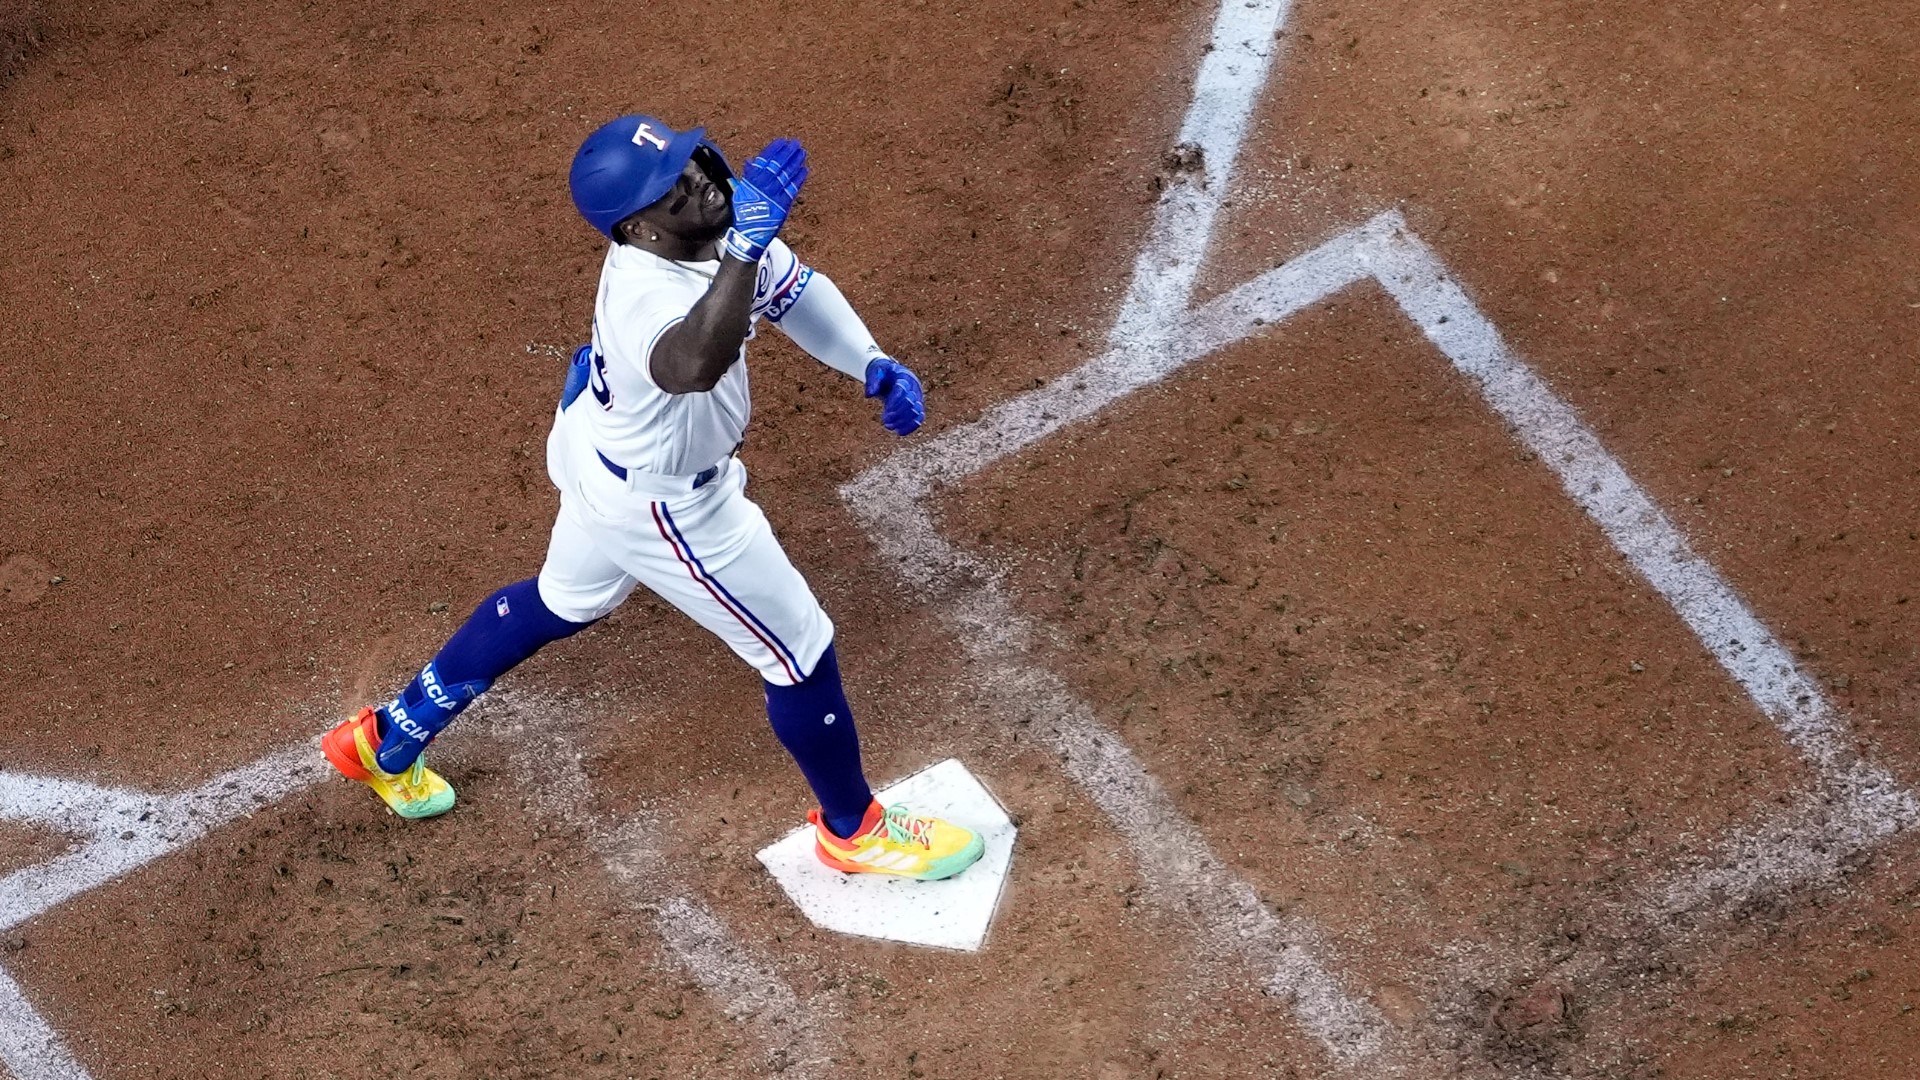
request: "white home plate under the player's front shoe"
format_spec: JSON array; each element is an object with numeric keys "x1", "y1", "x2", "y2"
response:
[{"x1": 760, "y1": 759, "x2": 1014, "y2": 953}]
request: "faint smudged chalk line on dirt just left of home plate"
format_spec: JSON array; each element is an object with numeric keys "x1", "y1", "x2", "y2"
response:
[{"x1": 468, "y1": 688, "x2": 835, "y2": 1080}]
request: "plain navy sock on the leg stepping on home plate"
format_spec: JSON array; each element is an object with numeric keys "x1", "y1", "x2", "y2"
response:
[{"x1": 766, "y1": 644, "x2": 874, "y2": 836}]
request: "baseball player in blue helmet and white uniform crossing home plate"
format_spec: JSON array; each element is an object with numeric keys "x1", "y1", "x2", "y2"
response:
[{"x1": 321, "y1": 115, "x2": 981, "y2": 880}]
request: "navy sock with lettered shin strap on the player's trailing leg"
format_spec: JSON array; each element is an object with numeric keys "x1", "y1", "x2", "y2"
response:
[{"x1": 376, "y1": 578, "x2": 589, "y2": 773}]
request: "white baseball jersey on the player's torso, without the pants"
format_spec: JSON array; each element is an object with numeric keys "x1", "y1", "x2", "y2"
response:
[{"x1": 568, "y1": 238, "x2": 810, "y2": 477}]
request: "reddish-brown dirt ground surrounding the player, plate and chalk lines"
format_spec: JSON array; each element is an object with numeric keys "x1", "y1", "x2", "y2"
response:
[{"x1": 0, "y1": 0, "x2": 1920, "y2": 1080}]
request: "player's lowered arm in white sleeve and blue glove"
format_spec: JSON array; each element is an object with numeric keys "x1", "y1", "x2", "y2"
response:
[{"x1": 764, "y1": 252, "x2": 927, "y2": 434}]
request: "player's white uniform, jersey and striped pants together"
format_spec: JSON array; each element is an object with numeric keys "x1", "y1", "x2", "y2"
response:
[{"x1": 540, "y1": 240, "x2": 833, "y2": 686}]
